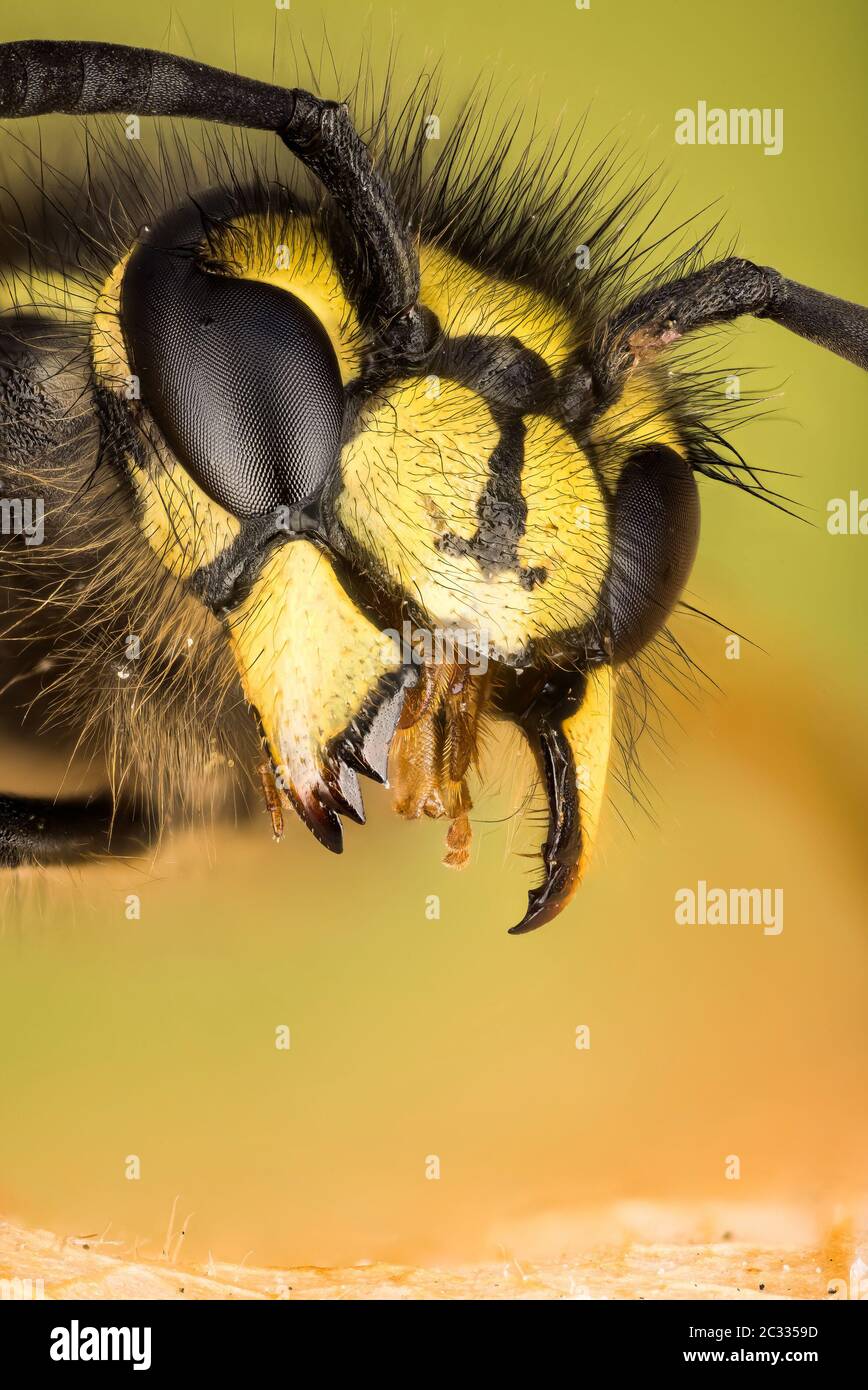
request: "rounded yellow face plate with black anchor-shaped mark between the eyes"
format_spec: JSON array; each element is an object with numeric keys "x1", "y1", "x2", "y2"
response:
[{"x1": 335, "y1": 378, "x2": 608, "y2": 659}]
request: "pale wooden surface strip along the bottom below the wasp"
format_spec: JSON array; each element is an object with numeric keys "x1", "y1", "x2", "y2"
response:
[{"x1": 0, "y1": 1209, "x2": 861, "y2": 1300}]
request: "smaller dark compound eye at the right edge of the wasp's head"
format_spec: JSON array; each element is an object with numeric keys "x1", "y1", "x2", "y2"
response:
[{"x1": 602, "y1": 445, "x2": 700, "y2": 662}]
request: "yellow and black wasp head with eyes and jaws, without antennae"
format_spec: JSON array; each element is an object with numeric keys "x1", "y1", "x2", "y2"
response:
[{"x1": 92, "y1": 196, "x2": 698, "y2": 931}]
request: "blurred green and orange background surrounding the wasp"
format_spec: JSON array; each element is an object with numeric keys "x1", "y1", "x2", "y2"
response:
[{"x1": 0, "y1": 0, "x2": 868, "y2": 1264}]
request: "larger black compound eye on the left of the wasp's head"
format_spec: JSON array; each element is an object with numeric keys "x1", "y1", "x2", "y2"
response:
[{"x1": 121, "y1": 246, "x2": 344, "y2": 518}]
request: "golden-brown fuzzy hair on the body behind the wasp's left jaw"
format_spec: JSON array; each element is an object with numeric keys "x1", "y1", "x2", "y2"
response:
[{"x1": 0, "y1": 358, "x2": 256, "y2": 831}]
